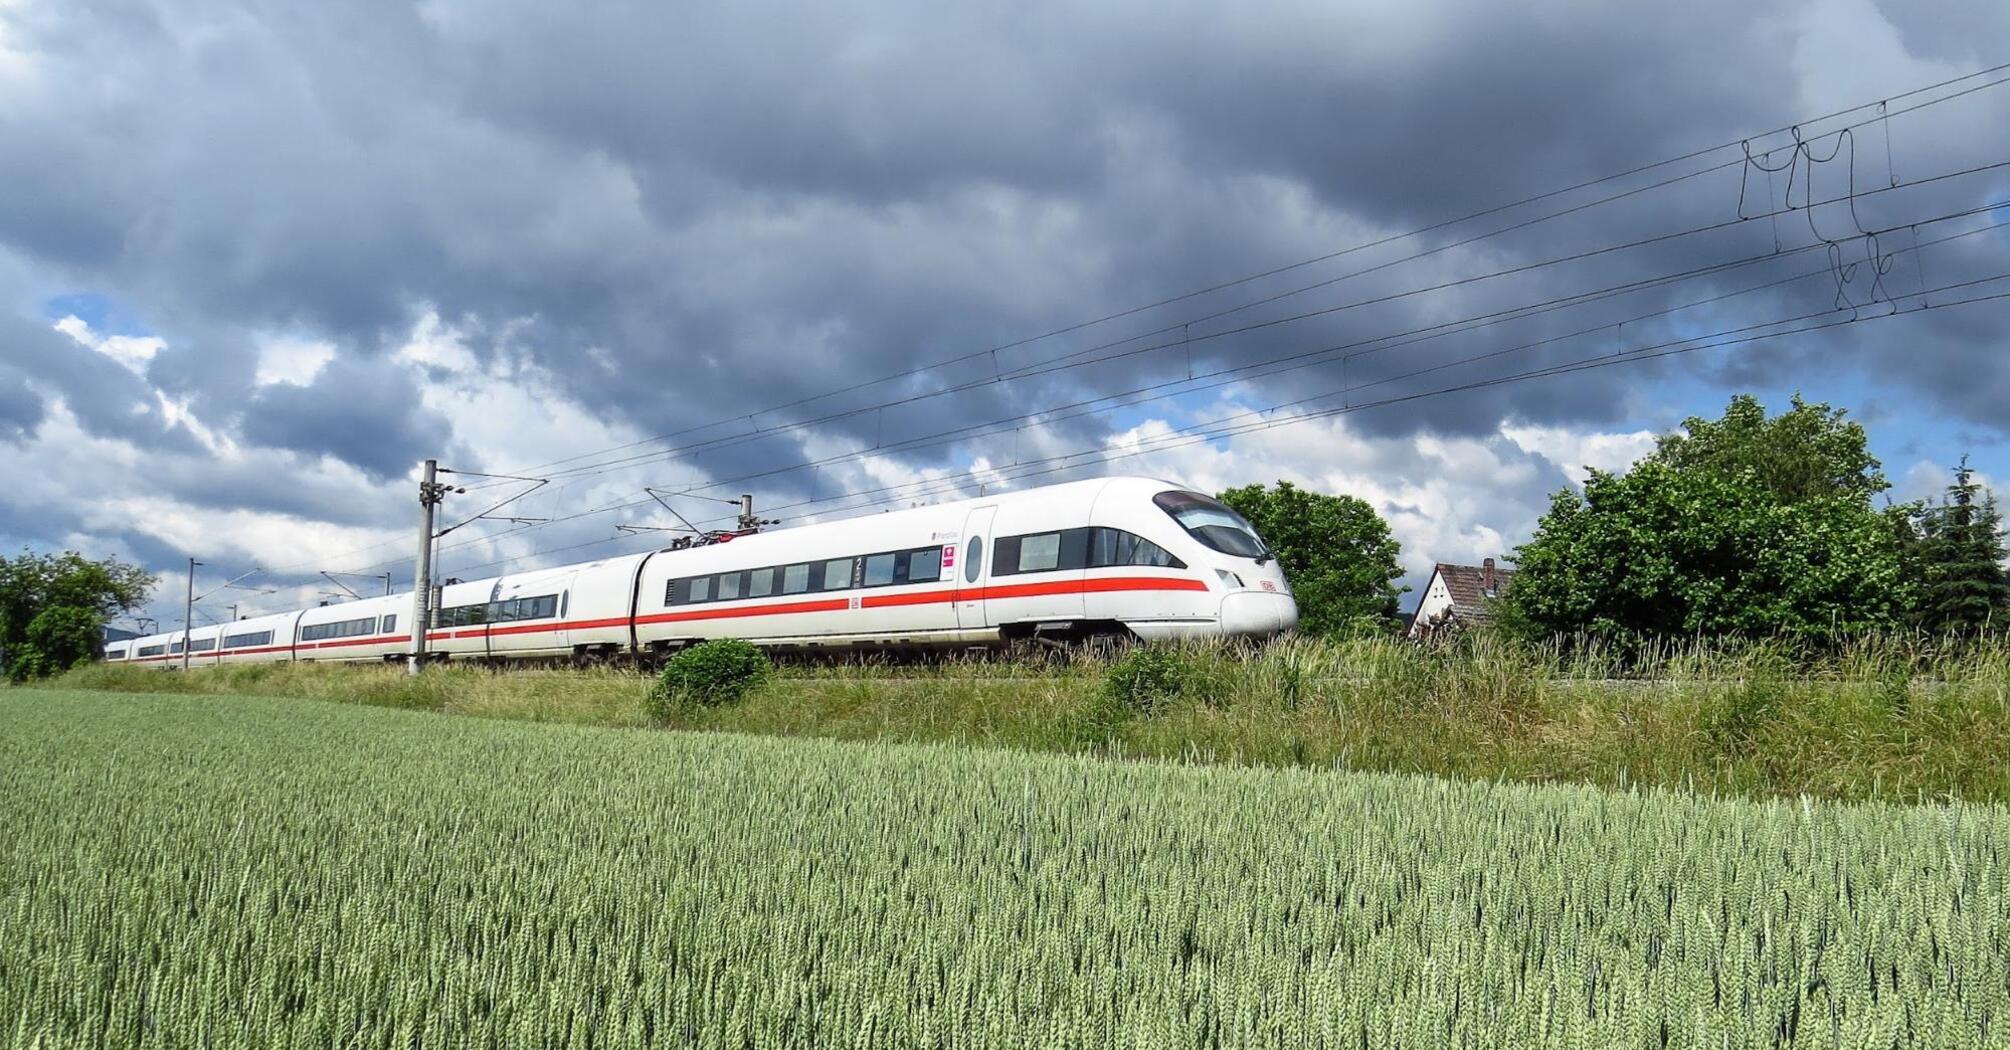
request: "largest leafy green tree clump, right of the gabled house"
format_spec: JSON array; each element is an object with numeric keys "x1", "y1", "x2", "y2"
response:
[{"x1": 1505, "y1": 396, "x2": 1914, "y2": 644}]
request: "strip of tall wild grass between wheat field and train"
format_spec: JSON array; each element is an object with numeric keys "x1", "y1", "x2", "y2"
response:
[{"x1": 39, "y1": 627, "x2": 2010, "y2": 801}]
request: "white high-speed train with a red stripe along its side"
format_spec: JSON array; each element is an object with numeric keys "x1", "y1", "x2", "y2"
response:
[{"x1": 105, "y1": 477, "x2": 1298, "y2": 668}]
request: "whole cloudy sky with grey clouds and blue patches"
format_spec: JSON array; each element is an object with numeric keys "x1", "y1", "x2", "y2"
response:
[{"x1": 0, "y1": 0, "x2": 2010, "y2": 622}]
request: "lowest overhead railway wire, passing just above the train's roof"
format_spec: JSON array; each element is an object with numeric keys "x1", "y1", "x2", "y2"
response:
[{"x1": 424, "y1": 272, "x2": 2010, "y2": 571}]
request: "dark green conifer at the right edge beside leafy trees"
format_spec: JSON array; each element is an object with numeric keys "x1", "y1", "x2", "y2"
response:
[{"x1": 1918, "y1": 457, "x2": 2010, "y2": 632}]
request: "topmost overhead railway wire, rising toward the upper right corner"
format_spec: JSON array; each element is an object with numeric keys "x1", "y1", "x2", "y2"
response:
[{"x1": 482, "y1": 62, "x2": 2010, "y2": 486}]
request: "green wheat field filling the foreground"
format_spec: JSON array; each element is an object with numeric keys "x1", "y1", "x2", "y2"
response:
[{"x1": 0, "y1": 690, "x2": 2010, "y2": 1048}]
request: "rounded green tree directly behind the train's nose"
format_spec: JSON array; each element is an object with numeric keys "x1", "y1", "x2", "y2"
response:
[{"x1": 1220, "y1": 481, "x2": 1407, "y2": 634}]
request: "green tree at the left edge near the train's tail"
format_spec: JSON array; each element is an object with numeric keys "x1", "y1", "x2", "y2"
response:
[{"x1": 0, "y1": 551, "x2": 155, "y2": 682}]
